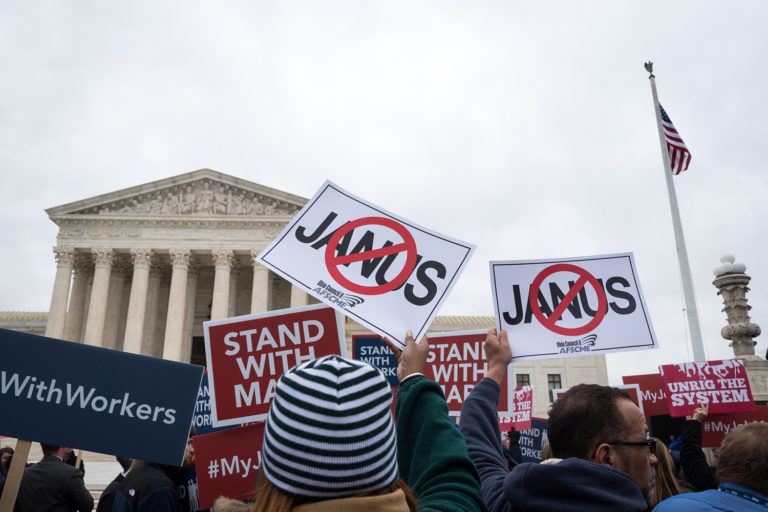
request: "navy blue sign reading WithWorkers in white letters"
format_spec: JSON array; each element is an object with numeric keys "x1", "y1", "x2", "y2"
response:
[{"x1": 0, "y1": 329, "x2": 203, "y2": 466}]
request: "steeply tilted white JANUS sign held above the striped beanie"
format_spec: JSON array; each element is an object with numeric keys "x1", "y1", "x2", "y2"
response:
[{"x1": 256, "y1": 181, "x2": 475, "y2": 347}]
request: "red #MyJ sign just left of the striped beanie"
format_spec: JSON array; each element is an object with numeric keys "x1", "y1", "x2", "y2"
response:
[{"x1": 192, "y1": 422, "x2": 264, "y2": 510}]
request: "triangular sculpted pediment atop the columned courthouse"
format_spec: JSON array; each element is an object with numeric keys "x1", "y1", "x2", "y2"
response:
[{"x1": 46, "y1": 169, "x2": 307, "y2": 222}]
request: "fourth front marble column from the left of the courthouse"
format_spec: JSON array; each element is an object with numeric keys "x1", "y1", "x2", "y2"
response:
[{"x1": 163, "y1": 249, "x2": 192, "y2": 361}]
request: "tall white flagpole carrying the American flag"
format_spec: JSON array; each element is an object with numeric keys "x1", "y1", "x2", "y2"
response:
[{"x1": 645, "y1": 62, "x2": 707, "y2": 361}]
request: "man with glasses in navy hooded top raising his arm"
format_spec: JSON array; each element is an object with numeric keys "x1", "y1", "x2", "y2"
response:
[{"x1": 461, "y1": 329, "x2": 657, "y2": 512}]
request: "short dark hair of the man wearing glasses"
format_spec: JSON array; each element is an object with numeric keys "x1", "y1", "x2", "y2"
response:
[{"x1": 547, "y1": 384, "x2": 632, "y2": 459}]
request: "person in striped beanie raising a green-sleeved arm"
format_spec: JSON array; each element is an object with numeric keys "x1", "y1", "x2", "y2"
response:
[{"x1": 252, "y1": 336, "x2": 485, "y2": 512}]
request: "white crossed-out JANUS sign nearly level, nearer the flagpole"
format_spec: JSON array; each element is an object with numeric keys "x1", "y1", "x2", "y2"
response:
[{"x1": 490, "y1": 253, "x2": 657, "y2": 361}]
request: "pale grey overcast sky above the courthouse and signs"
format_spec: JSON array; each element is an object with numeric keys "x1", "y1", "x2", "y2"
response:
[{"x1": 0, "y1": 0, "x2": 768, "y2": 382}]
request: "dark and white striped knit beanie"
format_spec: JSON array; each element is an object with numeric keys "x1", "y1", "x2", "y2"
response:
[{"x1": 261, "y1": 355, "x2": 398, "y2": 499}]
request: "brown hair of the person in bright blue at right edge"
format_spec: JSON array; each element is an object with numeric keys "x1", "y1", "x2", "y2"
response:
[{"x1": 717, "y1": 423, "x2": 768, "y2": 494}]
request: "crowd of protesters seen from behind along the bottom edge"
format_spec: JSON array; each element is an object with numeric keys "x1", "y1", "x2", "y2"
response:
[{"x1": 3, "y1": 329, "x2": 768, "y2": 512}]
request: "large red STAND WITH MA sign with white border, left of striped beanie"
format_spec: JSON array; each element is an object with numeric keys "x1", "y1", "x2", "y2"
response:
[{"x1": 203, "y1": 304, "x2": 347, "y2": 427}]
